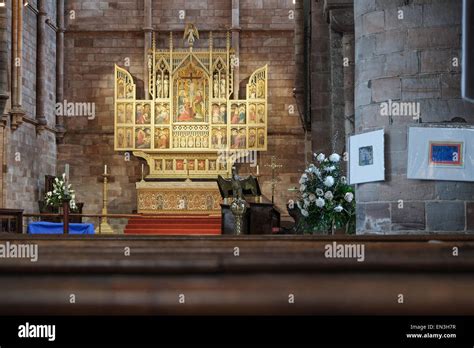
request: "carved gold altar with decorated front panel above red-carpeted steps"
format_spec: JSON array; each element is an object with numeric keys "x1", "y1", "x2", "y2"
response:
[{"x1": 136, "y1": 181, "x2": 222, "y2": 214}]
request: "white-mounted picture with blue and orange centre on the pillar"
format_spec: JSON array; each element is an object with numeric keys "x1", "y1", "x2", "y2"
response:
[{"x1": 407, "y1": 126, "x2": 474, "y2": 181}]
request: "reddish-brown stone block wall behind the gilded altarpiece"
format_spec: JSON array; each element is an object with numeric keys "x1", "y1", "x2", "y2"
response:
[{"x1": 58, "y1": 0, "x2": 305, "y2": 213}]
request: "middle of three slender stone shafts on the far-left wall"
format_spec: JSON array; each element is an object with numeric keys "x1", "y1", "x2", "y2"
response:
[{"x1": 36, "y1": 0, "x2": 47, "y2": 129}]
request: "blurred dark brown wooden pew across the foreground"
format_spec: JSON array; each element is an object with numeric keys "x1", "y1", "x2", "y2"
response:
[{"x1": 0, "y1": 234, "x2": 474, "y2": 315}]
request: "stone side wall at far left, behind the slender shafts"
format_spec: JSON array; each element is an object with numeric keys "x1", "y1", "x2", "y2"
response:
[{"x1": 2, "y1": 1, "x2": 56, "y2": 213}]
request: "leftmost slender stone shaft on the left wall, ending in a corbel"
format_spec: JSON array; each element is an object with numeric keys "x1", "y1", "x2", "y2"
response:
[{"x1": 10, "y1": 0, "x2": 25, "y2": 130}]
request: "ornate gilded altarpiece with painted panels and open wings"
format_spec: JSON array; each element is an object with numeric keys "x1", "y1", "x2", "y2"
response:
[{"x1": 115, "y1": 25, "x2": 268, "y2": 179}]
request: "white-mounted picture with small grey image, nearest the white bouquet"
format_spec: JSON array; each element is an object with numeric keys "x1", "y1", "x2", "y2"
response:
[{"x1": 348, "y1": 129, "x2": 385, "y2": 184}]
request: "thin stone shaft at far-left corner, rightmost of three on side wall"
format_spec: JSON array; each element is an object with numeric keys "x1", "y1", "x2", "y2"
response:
[{"x1": 56, "y1": 0, "x2": 66, "y2": 142}]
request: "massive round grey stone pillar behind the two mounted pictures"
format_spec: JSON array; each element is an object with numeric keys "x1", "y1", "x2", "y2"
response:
[{"x1": 354, "y1": 0, "x2": 474, "y2": 234}]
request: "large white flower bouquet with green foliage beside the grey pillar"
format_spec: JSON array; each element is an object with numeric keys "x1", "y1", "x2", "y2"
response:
[{"x1": 296, "y1": 153, "x2": 355, "y2": 234}]
